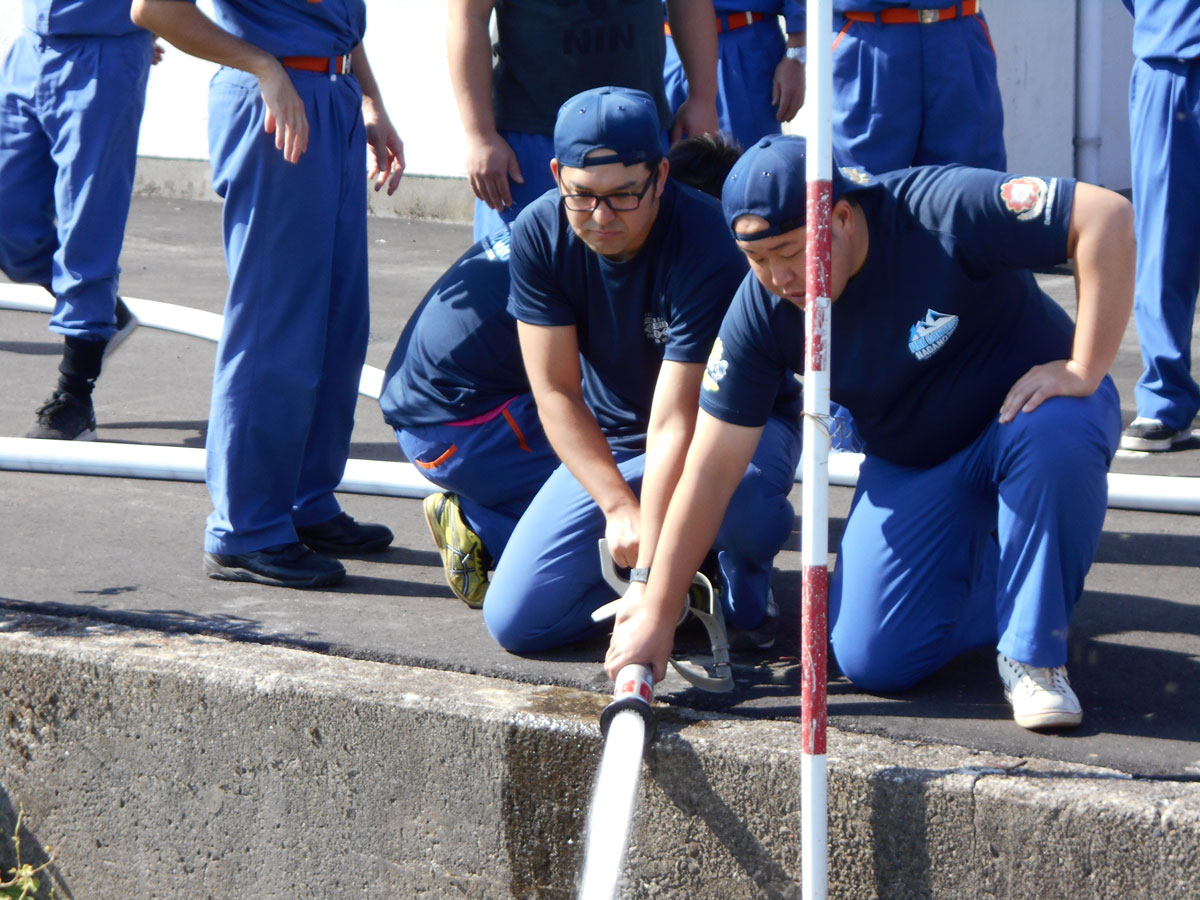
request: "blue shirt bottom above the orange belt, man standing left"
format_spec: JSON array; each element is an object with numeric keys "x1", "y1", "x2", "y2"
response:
[{"x1": 180, "y1": 0, "x2": 367, "y2": 56}]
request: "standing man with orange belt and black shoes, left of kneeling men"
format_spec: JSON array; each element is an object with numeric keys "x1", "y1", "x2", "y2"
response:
[{"x1": 133, "y1": 0, "x2": 404, "y2": 588}]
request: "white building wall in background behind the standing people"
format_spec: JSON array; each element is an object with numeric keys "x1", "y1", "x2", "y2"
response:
[{"x1": 0, "y1": 0, "x2": 1133, "y2": 188}]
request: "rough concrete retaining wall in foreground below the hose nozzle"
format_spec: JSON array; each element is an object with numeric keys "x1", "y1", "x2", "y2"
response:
[{"x1": 0, "y1": 614, "x2": 1200, "y2": 900}]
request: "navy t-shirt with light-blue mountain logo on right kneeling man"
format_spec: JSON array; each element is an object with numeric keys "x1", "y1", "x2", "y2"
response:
[{"x1": 701, "y1": 166, "x2": 1075, "y2": 466}]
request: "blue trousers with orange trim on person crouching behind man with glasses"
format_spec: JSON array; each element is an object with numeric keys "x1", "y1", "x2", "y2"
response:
[{"x1": 396, "y1": 394, "x2": 558, "y2": 559}]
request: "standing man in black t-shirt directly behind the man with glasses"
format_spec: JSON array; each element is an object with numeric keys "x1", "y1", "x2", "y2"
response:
[{"x1": 446, "y1": 0, "x2": 716, "y2": 240}]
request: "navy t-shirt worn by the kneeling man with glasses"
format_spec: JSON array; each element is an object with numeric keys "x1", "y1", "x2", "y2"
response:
[{"x1": 509, "y1": 181, "x2": 753, "y2": 451}]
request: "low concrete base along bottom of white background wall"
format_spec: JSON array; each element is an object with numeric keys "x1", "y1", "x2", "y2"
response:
[{"x1": 133, "y1": 156, "x2": 475, "y2": 223}]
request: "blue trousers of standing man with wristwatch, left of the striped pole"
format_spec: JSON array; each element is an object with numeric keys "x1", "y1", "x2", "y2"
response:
[{"x1": 662, "y1": 16, "x2": 785, "y2": 152}]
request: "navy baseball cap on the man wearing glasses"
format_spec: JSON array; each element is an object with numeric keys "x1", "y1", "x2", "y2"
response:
[{"x1": 554, "y1": 88, "x2": 662, "y2": 168}]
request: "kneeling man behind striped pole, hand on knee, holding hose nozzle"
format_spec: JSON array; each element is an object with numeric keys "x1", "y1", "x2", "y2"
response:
[{"x1": 606, "y1": 137, "x2": 1134, "y2": 728}]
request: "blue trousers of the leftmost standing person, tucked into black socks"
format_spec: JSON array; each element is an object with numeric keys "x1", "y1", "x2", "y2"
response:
[{"x1": 0, "y1": 29, "x2": 154, "y2": 341}]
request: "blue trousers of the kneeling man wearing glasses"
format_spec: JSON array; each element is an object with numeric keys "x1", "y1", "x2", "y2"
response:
[{"x1": 484, "y1": 416, "x2": 800, "y2": 653}]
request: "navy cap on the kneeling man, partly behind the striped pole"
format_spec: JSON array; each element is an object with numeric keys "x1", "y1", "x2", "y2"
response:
[{"x1": 721, "y1": 134, "x2": 875, "y2": 240}]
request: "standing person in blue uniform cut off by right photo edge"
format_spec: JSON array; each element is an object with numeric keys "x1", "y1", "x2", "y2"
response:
[{"x1": 1121, "y1": 0, "x2": 1200, "y2": 450}]
